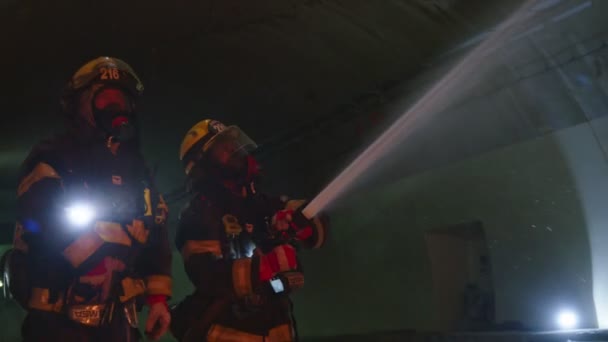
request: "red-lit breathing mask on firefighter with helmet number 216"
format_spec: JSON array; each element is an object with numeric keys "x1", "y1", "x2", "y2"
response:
[{"x1": 91, "y1": 87, "x2": 136, "y2": 142}]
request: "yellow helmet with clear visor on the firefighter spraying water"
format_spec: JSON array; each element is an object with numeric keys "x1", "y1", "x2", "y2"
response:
[{"x1": 179, "y1": 119, "x2": 257, "y2": 175}]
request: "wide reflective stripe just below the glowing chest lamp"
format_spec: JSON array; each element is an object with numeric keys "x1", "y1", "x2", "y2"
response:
[{"x1": 63, "y1": 221, "x2": 131, "y2": 267}]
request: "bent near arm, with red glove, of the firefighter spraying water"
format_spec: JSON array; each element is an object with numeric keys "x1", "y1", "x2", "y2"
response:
[{"x1": 176, "y1": 200, "x2": 316, "y2": 298}]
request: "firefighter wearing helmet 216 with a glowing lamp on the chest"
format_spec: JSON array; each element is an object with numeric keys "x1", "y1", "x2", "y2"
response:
[{"x1": 10, "y1": 57, "x2": 171, "y2": 341}]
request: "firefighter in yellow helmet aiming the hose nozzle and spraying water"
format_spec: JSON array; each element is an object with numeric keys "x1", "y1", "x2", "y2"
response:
[{"x1": 171, "y1": 120, "x2": 327, "y2": 342}]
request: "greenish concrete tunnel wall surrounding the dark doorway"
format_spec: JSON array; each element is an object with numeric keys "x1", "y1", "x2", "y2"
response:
[{"x1": 296, "y1": 119, "x2": 608, "y2": 336}]
